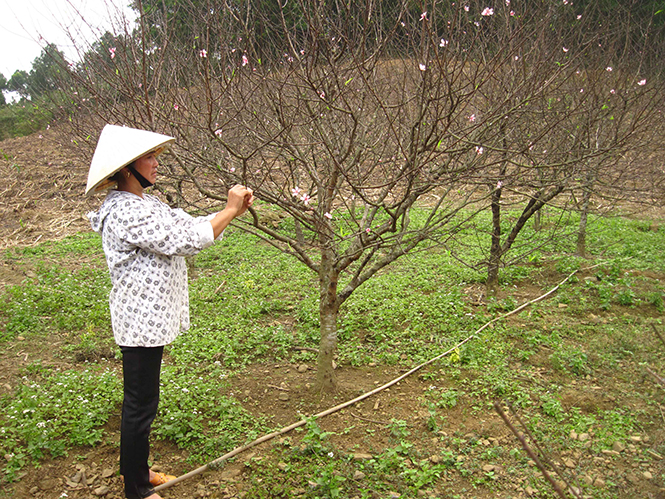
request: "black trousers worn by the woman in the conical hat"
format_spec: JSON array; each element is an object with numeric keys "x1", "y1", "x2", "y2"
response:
[{"x1": 120, "y1": 346, "x2": 164, "y2": 499}]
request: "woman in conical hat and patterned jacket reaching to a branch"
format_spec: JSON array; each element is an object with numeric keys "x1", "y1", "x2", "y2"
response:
[{"x1": 86, "y1": 125, "x2": 254, "y2": 499}]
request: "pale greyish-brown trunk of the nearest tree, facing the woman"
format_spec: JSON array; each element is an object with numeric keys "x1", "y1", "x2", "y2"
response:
[{"x1": 316, "y1": 244, "x2": 339, "y2": 392}]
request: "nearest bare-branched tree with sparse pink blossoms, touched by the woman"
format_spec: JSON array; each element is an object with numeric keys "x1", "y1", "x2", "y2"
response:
[{"x1": 58, "y1": 0, "x2": 664, "y2": 389}]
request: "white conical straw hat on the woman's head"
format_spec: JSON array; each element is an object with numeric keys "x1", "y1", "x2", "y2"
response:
[{"x1": 85, "y1": 125, "x2": 175, "y2": 196}]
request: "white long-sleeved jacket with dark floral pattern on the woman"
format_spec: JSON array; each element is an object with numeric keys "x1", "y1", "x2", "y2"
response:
[{"x1": 88, "y1": 190, "x2": 222, "y2": 347}]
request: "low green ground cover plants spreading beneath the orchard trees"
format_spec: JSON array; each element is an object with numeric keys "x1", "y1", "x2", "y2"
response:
[{"x1": 0, "y1": 209, "x2": 665, "y2": 498}]
